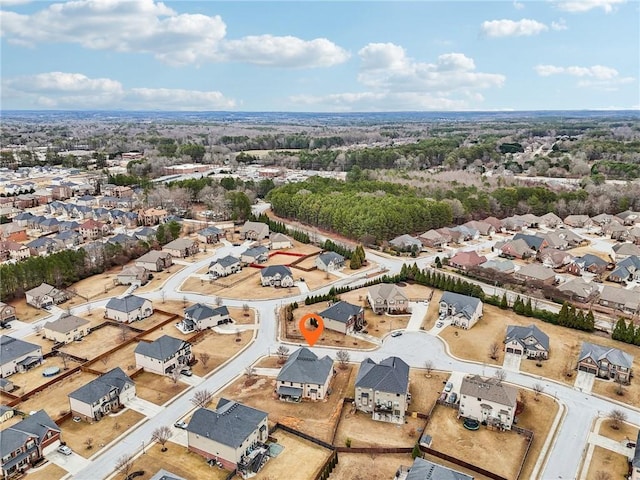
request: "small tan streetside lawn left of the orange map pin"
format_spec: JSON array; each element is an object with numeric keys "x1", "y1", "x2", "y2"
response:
[{"x1": 190, "y1": 330, "x2": 253, "y2": 376}]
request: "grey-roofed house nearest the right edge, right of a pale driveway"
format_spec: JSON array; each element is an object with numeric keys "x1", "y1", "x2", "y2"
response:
[{"x1": 578, "y1": 342, "x2": 633, "y2": 383}]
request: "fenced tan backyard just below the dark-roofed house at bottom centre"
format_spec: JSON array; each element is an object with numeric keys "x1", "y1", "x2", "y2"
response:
[{"x1": 334, "y1": 405, "x2": 425, "y2": 448}]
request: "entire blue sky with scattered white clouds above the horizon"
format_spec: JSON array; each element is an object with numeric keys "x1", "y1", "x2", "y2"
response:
[{"x1": 0, "y1": 0, "x2": 640, "y2": 112}]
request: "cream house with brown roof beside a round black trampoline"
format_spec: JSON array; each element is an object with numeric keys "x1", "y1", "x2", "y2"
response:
[{"x1": 458, "y1": 375, "x2": 518, "y2": 430}]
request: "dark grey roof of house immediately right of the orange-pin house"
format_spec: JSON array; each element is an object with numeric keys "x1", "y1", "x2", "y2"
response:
[{"x1": 356, "y1": 357, "x2": 409, "y2": 394}]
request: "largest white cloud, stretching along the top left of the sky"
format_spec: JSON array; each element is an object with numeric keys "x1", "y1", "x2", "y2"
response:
[{"x1": 0, "y1": 0, "x2": 349, "y2": 67}]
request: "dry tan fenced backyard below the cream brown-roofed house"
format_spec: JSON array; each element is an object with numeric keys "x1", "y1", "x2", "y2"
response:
[{"x1": 427, "y1": 405, "x2": 535, "y2": 478}]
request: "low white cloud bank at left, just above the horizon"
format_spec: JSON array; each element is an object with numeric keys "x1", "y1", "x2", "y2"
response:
[{"x1": 2, "y1": 72, "x2": 236, "y2": 110}]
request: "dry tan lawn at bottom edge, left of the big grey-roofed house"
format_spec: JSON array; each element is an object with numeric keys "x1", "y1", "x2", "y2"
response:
[{"x1": 117, "y1": 442, "x2": 229, "y2": 480}]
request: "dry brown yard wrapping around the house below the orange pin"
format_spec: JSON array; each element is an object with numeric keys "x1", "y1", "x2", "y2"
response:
[{"x1": 212, "y1": 367, "x2": 356, "y2": 442}]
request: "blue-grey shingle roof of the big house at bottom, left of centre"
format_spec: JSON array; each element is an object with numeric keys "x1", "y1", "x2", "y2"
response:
[{"x1": 187, "y1": 398, "x2": 267, "y2": 448}]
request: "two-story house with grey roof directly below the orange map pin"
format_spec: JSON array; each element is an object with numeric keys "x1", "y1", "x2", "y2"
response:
[{"x1": 276, "y1": 347, "x2": 334, "y2": 402}]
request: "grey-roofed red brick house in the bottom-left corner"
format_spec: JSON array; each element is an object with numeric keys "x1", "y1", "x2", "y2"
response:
[{"x1": 0, "y1": 410, "x2": 60, "y2": 478}]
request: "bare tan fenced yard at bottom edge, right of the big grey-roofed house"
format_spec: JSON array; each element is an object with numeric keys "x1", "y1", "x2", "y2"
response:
[{"x1": 255, "y1": 430, "x2": 331, "y2": 480}]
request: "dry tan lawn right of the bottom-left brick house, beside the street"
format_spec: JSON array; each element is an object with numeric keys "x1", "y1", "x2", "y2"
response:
[{"x1": 61, "y1": 409, "x2": 143, "y2": 458}]
